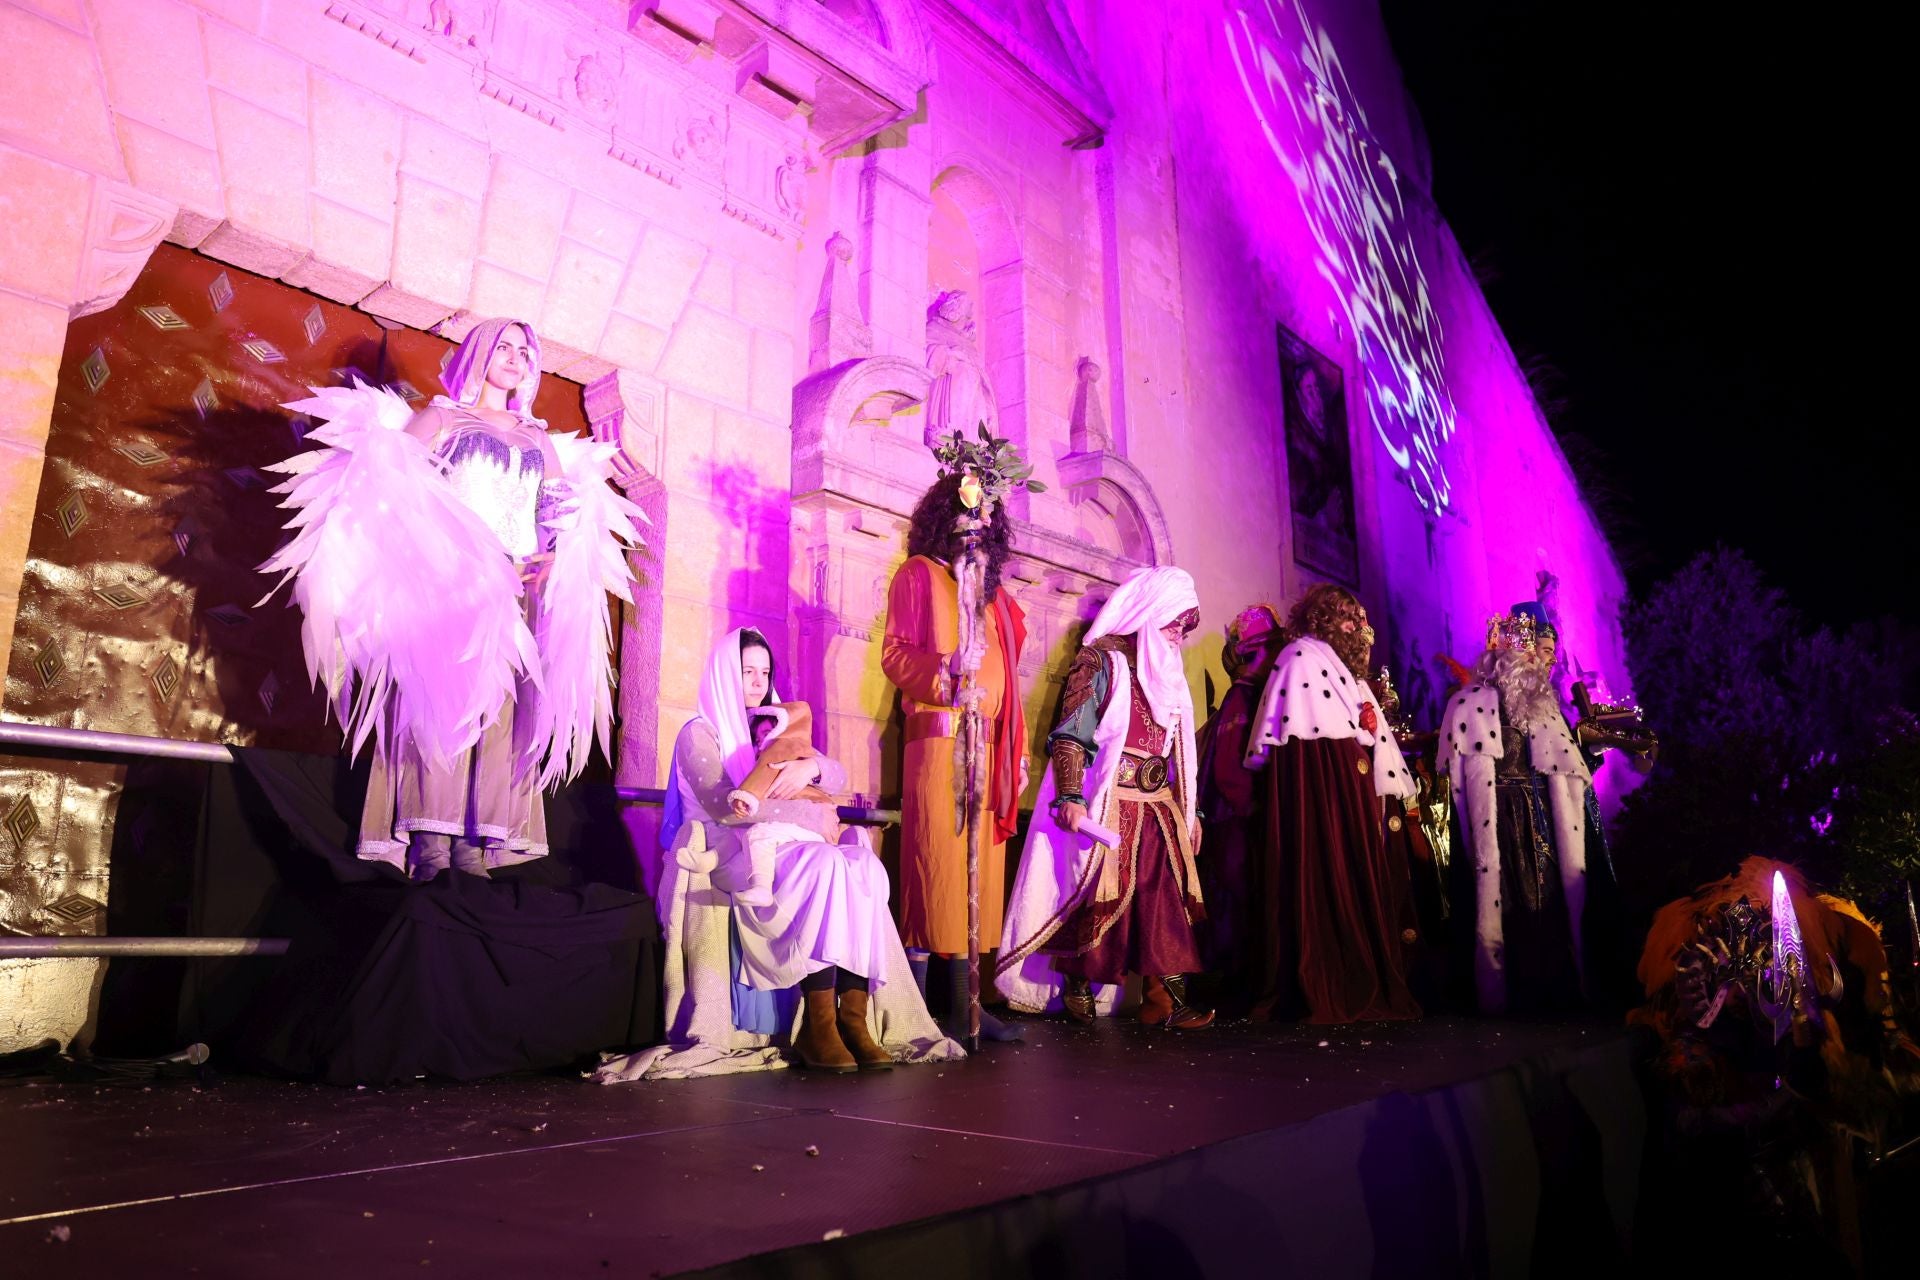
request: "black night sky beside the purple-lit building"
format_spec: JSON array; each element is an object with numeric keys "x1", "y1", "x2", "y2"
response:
[{"x1": 1380, "y1": 0, "x2": 1920, "y2": 626}]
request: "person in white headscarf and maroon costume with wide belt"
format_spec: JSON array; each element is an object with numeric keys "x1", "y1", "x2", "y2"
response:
[{"x1": 998, "y1": 568, "x2": 1213, "y2": 1031}]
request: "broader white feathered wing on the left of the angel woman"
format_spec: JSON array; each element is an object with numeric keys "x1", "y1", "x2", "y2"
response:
[{"x1": 261, "y1": 386, "x2": 540, "y2": 766}]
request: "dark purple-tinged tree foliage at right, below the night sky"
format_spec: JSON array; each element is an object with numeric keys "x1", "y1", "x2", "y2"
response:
[{"x1": 1617, "y1": 547, "x2": 1920, "y2": 940}]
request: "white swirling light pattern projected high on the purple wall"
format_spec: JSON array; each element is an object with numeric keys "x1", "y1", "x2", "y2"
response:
[{"x1": 1227, "y1": 0, "x2": 1455, "y2": 516}]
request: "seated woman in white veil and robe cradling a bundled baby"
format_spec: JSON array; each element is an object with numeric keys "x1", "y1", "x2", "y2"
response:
[{"x1": 595, "y1": 631, "x2": 962, "y2": 1082}]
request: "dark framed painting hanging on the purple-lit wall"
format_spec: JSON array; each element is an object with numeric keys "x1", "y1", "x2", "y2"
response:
[{"x1": 1277, "y1": 324, "x2": 1359, "y2": 587}]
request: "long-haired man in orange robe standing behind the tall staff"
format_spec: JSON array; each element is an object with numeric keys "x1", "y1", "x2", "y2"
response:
[{"x1": 881, "y1": 476, "x2": 1027, "y2": 1040}]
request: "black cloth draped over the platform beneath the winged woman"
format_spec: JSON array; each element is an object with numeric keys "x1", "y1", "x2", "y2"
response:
[{"x1": 129, "y1": 750, "x2": 660, "y2": 1084}]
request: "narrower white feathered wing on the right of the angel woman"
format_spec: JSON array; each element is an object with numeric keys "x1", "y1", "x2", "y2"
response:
[{"x1": 524, "y1": 436, "x2": 647, "y2": 787}]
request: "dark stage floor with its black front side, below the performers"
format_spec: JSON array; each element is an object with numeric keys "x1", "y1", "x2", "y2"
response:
[{"x1": 0, "y1": 1017, "x2": 1642, "y2": 1278}]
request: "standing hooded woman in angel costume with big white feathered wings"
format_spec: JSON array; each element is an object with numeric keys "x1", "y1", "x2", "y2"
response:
[{"x1": 263, "y1": 320, "x2": 643, "y2": 881}]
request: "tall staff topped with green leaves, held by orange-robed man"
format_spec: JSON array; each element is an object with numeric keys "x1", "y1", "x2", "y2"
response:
[{"x1": 933, "y1": 422, "x2": 1046, "y2": 1054}]
